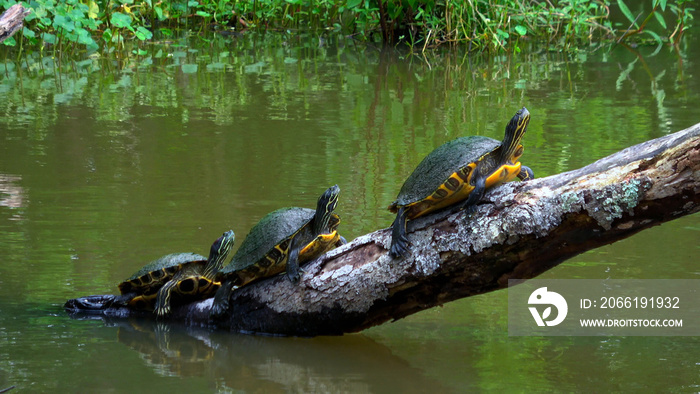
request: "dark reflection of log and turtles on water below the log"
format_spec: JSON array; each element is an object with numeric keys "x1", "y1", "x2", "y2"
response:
[{"x1": 79, "y1": 317, "x2": 446, "y2": 393}]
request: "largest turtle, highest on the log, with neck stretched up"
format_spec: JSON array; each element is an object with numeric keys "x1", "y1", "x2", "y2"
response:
[{"x1": 388, "y1": 107, "x2": 535, "y2": 257}]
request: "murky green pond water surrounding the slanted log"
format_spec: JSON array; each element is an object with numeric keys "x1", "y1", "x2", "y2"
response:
[{"x1": 0, "y1": 35, "x2": 700, "y2": 392}]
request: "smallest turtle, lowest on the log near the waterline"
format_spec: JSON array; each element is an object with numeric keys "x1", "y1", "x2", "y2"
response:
[{"x1": 118, "y1": 230, "x2": 236, "y2": 317}]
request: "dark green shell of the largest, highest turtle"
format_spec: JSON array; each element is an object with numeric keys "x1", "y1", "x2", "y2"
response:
[{"x1": 395, "y1": 136, "x2": 501, "y2": 206}]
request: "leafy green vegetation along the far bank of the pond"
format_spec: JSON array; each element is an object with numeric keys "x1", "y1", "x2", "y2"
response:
[{"x1": 0, "y1": 0, "x2": 693, "y2": 52}]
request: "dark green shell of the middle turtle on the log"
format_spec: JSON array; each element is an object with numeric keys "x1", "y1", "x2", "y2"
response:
[{"x1": 220, "y1": 208, "x2": 316, "y2": 275}]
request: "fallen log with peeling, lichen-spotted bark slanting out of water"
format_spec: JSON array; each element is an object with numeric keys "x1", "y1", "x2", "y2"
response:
[{"x1": 67, "y1": 124, "x2": 700, "y2": 336}]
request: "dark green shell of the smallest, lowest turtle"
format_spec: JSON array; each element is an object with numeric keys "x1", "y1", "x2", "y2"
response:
[{"x1": 119, "y1": 253, "x2": 207, "y2": 294}]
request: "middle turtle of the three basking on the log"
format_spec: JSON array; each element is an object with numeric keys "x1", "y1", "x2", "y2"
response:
[{"x1": 211, "y1": 185, "x2": 346, "y2": 317}]
